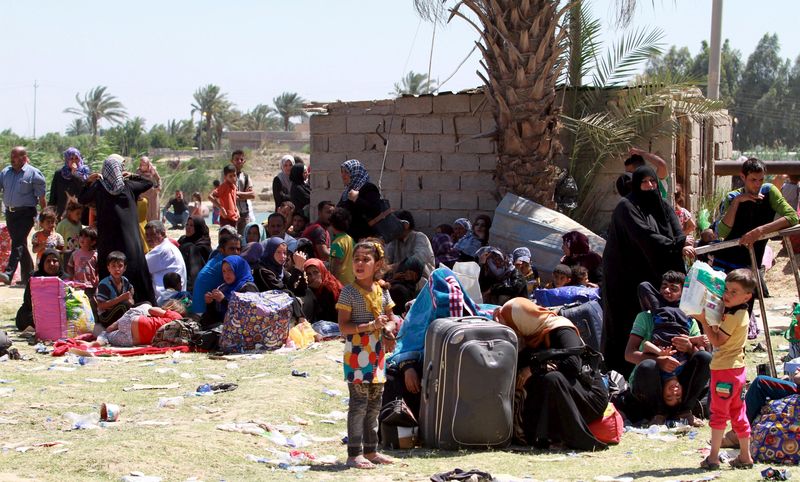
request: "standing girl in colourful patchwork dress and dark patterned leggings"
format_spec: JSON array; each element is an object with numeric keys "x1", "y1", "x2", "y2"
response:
[{"x1": 336, "y1": 240, "x2": 394, "y2": 469}]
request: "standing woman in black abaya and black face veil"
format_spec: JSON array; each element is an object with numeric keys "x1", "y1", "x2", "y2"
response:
[{"x1": 602, "y1": 166, "x2": 694, "y2": 378}]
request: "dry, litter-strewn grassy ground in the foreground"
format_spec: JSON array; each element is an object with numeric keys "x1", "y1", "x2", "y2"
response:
[{"x1": 0, "y1": 239, "x2": 794, "y2": 481}]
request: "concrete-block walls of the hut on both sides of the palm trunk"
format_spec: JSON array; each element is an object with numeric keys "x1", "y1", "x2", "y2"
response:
[{"x1": 310, "y1": 91, "x2": 732, "y2": 234}]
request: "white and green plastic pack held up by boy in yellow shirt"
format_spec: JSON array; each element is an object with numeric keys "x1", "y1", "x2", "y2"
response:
[{"x1": 679, "y1": 261, "x2": 725, "y2": 325}]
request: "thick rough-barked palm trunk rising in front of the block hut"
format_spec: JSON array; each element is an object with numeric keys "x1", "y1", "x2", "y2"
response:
[{"x1": 414, "y1": 0, "x2": 569, "y2": 207}]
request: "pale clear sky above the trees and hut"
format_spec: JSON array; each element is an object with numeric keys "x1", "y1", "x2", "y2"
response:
[{"x1": 0, "y1": 0, "x2": 800, "y2": 136}]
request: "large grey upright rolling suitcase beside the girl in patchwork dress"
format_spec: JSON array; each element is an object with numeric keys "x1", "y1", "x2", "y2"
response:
[{"x1": 419, "y1": 316, "x2": 517, "y2": 450}]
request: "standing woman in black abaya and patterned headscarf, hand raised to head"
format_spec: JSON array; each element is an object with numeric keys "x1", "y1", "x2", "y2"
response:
[{"x1": 78, "y1": 154, "x2": 155, "y2": 304}]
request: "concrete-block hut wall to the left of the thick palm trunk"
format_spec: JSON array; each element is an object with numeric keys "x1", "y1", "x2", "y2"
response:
[{"x1": 309, "y1": 93, "x2": 499, "y2": 234}]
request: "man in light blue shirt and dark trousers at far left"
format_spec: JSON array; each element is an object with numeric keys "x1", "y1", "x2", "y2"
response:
[{"x1": 0, "y1": 146, "x2": 46, "y2": 284}]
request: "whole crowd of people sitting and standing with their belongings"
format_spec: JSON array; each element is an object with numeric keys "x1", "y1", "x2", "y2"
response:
[{"x1": 0, "y1": 147, "x2": 798, "y2": 468}]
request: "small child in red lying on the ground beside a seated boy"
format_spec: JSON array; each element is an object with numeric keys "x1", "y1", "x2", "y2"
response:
[{"x1": 97, "y1": 300, "x2": 186, "y2": 347}]
